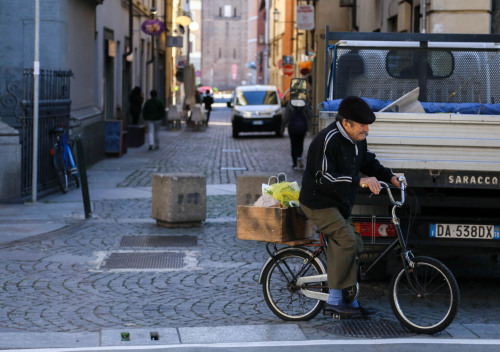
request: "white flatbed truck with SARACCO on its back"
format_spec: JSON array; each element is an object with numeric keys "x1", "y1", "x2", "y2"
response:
[{"x1": 319, "y1": 29, "x2": 500, "y2": 268}]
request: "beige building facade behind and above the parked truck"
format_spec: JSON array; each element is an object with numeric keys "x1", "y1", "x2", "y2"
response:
[{"x1": 292, "y1": 0, "x2": 500, "y2": 113}]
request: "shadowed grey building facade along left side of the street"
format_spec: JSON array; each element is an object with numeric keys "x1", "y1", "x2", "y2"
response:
[{"x1": 0, "y1": 0, "x2": 178, "y2": 199}]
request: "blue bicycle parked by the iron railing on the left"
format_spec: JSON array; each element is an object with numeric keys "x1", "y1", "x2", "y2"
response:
[{"x1": 49, "y1": 125, "x2": 80, "y2": 193}]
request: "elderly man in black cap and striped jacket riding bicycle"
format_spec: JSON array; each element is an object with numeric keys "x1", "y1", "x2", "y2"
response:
[{"x1": 299, "y1": 96, "x2": 401, "y2": 315}]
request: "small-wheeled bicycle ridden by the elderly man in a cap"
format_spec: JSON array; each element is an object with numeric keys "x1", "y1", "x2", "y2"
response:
[{"x1": 259, "y1": 177, "x2": 460, "y2": 334}]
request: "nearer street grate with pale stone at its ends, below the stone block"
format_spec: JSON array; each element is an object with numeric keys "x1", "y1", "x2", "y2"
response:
[{"x1": 102, "y1": 252, "x2": 185, "y2": 269}]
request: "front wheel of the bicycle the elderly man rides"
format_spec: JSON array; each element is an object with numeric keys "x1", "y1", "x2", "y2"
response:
[{"x1": 389, "y1": 257, "x2": 460, "y2": 334}]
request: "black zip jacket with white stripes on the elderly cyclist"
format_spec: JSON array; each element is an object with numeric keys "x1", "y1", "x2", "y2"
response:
[{"x1": 299, "y1": 122, "x2": 394, "y2": 219}]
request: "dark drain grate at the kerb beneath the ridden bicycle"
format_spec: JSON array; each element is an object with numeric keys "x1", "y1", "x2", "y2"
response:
[{"x1": 335, "y1": 320, "x2": 412, "y2": 338}]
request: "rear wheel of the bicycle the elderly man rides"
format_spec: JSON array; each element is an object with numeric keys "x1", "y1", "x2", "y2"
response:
[{"x1": 262, "y1": 249, "x2": 328, "y2": 321}]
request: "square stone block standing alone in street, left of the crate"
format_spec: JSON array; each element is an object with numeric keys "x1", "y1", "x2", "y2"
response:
[{"x1": 151, "y1": 173, "x2": 207, "y2": 227}]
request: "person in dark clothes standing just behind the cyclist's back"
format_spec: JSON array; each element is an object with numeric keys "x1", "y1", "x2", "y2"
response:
[{"x1": 285, "y1": 102, "x2": 310, "y2": 170}]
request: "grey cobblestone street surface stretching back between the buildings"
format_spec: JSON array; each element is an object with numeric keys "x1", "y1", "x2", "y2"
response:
[{"x1": 0, "y1": 108, "x2": 500, "y2": 347}]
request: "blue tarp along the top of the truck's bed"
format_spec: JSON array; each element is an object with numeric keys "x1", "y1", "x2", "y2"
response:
[{"x1": 319, "y1": 98, "x2": 500, "y2": 115}]
